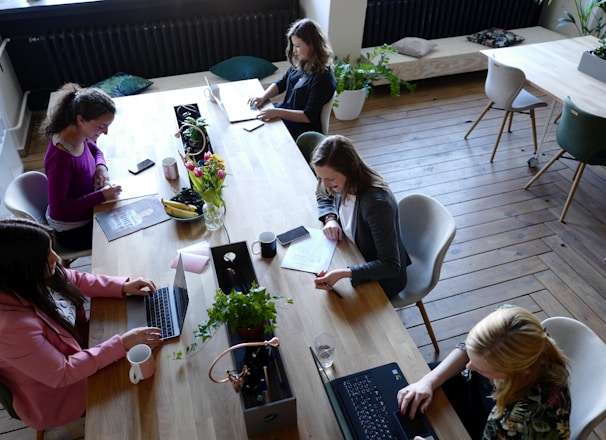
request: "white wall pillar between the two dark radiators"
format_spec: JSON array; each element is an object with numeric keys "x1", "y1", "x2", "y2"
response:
[{"x1": 299, "y1": 0, "x2": 366, "y2": 59}]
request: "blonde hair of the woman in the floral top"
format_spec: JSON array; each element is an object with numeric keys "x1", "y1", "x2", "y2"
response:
[{"x1": 466, "y1": 307, "x2": 568, "y2": 417}]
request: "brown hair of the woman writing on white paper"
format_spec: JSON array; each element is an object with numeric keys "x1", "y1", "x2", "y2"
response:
[{"x1": 310, "y1": 135, "x2": 389, "y2": 197}]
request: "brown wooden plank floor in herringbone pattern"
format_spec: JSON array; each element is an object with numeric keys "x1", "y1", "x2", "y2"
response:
[{"x1": 5, "y1": 73, "x2": 606, "y2": 440}]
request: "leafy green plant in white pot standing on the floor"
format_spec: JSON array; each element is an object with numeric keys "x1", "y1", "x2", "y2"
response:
[{"x1": 333, "y1": 44, "x2": 416, "y2": 120}]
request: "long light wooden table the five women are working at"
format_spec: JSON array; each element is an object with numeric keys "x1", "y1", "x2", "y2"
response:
[{"x1": 86, "y1": 82, "x2": 468, "y2": 440}]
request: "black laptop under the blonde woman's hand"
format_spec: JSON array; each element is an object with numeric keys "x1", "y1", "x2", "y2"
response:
[{"x1": 309, "y1": 347, "x2": 438, "y2": 440}]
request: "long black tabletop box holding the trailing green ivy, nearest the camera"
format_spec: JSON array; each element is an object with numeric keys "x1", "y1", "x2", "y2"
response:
[{"x1": 211, "y1": 242, "x2": 297, "y2": 436}]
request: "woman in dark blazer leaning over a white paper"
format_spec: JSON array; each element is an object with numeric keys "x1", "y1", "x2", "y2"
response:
[{"x1": 311, "y1": 136, "x2": 410, "y2": 298}]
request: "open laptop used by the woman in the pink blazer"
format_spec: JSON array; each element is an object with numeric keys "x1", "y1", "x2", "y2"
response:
[{"x1": 126, "y1": 254, "x2": 189, "y2": 339}]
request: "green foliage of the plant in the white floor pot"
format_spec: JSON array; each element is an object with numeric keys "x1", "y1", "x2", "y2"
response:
[{"x1": 334, "y1": 44, "x2": 416, "y2": 107}]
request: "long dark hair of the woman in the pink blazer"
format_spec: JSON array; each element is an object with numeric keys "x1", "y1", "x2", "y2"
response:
[{"x1": 0, "y1": 218, "x2": 87, "y2": 344}]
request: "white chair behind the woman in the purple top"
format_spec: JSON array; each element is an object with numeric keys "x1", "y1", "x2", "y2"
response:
[{"x1": 4, "y1": 171, "x2": 92, "y2": 267}]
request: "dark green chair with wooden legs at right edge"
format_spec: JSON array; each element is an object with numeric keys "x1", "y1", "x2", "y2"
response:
[{"x1": 524, "y1": 96, "x2": 606, "y2": 223}]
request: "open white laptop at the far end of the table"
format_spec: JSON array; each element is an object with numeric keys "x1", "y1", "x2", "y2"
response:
[{"x1": 204, "y1": 77, "x2": 263, "y2": 122}]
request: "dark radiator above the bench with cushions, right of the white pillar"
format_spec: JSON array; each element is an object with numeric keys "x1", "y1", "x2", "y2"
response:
[{"x1": 362, "y1": 0, "x2": 541, "y2": 47}]
